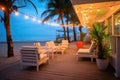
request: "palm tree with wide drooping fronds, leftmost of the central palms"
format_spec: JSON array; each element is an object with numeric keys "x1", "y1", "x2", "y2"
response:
[{"x1": 41, "y1": 0, "x2": 68, "y2": 39}]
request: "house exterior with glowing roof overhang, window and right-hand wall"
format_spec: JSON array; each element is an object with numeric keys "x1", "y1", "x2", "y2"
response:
[{"x1": 71, "y1": 0, "x2": 120, "y2": 77}]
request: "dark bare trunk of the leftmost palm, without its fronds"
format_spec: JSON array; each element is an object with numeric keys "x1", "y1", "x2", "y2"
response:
[{"x1": 4, "y1": 11, "x2": 14, "y2": 57}]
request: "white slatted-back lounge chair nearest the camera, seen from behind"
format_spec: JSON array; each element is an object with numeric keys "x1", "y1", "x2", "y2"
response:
[{"x1": 20, "y1": 46, "x2": 49, "y2": 71}]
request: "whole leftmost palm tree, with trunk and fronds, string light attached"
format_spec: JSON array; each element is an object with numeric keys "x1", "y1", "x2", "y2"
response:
[{"x1": 0, "y1": 0, "x2": 37, "y2": 57}]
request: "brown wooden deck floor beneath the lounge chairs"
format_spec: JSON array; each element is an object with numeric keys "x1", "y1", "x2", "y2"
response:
[{"x1": 0, "y1": 43, "x2": 119, "y2": 80}]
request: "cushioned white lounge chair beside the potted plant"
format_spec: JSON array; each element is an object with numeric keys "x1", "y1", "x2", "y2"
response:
[{"x1": 76, "y1": 42, "x2": 96, "y2": 62}]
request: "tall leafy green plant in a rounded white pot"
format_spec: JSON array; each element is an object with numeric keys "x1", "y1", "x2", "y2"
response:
[{"x1": 90, "y1": 23, "x2": 111, "y2": 70}]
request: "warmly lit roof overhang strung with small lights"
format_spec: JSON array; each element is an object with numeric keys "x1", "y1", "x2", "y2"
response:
[{"x1": 71, "y1": 0, "x2": 120, "y2": 27}]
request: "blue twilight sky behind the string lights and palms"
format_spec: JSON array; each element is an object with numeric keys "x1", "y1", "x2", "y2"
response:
[{"x1": 0, "y1": 0, "x2": 86, "y2": 42}]
